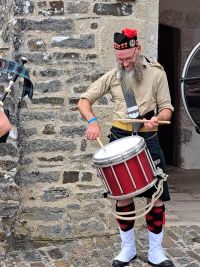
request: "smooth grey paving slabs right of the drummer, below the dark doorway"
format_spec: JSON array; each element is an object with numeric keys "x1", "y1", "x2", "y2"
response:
[{"x1": 166, "y1": 167, "x2": 200, "y2": 226}]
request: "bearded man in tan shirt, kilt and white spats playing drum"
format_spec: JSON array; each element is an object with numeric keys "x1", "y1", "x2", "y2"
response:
[{"x1": 78, "y1": 28, "x2": 174, "y2": 267}]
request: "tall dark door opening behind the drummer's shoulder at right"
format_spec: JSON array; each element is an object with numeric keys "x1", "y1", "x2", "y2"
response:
[{"x1": 158, "y1": 24, "x2": 181, "y2": 166}]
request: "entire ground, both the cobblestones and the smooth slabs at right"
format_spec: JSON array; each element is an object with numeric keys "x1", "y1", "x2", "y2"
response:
[{"x1": 0, "y1": 168, "x2": 200, "y2": 267}]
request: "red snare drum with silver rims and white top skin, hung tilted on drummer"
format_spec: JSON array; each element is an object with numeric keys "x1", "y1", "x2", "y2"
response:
[{"x1": 93, "y1": 136, "x2": 157, "y2": 200}]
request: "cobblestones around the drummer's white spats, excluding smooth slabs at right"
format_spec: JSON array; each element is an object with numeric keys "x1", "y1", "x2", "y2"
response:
[{"x1": 0, "y1": 225, "x2": 200, "y2": 267}]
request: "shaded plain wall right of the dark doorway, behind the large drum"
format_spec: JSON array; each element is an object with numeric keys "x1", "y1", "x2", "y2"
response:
[{"x1": 160, "y1": 0, "x2": 200, "y2": 169}]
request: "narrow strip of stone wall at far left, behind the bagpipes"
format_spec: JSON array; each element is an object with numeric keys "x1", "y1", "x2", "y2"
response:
[{"x1": 0, "y1": 0, "x2": 19, "y2": 260}]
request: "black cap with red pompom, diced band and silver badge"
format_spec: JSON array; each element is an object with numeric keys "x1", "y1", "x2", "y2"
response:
[{"x1": 114, "y1": 28, "x2": 138, "y2": 50}]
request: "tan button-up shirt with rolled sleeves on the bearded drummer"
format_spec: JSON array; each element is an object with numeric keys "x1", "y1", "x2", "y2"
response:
[{"x1": 80, "y1": 58, "x2": 174, "y2": 119}]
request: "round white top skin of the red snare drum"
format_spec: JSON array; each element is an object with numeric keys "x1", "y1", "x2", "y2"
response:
[{"x1": 93, "y1": 136, "x2": 146, "y2": 166}]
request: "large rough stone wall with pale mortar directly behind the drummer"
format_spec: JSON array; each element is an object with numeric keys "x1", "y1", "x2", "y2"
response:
[{"x1": 2, "y1": 0, "x2": 158, "y2": 251}]
